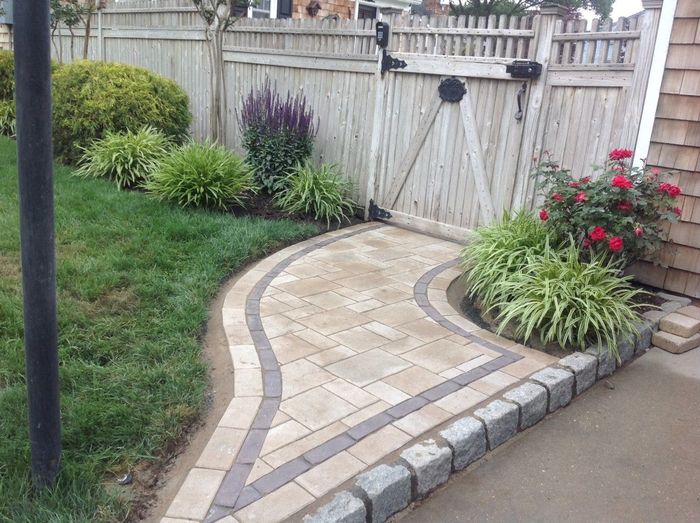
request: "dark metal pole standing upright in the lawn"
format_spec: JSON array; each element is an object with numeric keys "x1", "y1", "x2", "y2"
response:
[{"x1": 15, "y1": 0, "x2": 61, "y2": 487}]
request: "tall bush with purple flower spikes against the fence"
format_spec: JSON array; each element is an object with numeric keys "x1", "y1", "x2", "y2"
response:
[{"x1": 238, "y1": 81, "x2": 316, "y2": 193}]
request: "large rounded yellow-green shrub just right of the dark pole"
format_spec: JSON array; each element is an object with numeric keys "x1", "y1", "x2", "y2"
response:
[{"x1": 53, "y1": 61, "x2": 192, "y2": 163}]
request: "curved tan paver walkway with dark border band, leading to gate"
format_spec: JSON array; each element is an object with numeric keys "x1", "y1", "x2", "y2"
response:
[{"x1": 163, "y1": 223, "x2": 555, "y2": 523}]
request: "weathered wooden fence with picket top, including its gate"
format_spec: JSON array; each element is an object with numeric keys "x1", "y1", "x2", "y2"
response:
[{"x1": 54, "y1": 0, "x2": 659, "y2": 238}]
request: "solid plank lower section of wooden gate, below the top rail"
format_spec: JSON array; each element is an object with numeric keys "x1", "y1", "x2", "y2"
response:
[{"x1": 375, "y1": 69, "x2": 529, "y2": 238}]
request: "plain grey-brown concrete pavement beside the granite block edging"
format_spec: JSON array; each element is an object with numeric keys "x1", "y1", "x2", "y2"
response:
[{"x1": 398, "y1": 349, "x2": 700, "y2": 523}]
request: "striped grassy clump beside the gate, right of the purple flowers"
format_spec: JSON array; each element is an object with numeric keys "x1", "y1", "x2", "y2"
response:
[{"x1": 275, "y1": 161, "x2": 356, "y2": 226}]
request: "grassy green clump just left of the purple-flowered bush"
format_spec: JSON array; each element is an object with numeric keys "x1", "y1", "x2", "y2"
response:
[{"x1": 146, "y1": 143, "x2": 255, "y2": 210}]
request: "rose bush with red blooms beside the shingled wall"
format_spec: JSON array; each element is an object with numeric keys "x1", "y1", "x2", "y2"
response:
[{"x1": 537, "y1": 149, "x2": 681, "y2": 265}]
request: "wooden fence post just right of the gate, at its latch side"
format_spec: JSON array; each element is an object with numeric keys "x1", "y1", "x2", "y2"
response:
[{"x1": 512, "y1": 5, "x2": 566, "y2": 209}]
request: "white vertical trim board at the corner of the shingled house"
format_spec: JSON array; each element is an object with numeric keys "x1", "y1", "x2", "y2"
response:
[{"x1": 634, "y1": 0, "x2": 678, "y2": 167}]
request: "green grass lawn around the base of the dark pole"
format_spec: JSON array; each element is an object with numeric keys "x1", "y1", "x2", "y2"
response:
[{"x1": 0, "y1": 138, "x2": 316, "y2": 523}]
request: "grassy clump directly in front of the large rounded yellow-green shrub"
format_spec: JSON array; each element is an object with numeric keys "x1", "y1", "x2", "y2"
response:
[{"x1": 75, "y1": 127, "x2": 170, "y2": 189}]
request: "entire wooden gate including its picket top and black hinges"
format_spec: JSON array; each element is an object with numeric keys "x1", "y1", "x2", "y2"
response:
[{"x1": 368, "y1": 17, "x2": 541, "y2": 240}]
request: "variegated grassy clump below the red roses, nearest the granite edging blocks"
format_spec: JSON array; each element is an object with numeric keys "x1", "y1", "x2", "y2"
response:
[{"x1": 495, "y1": 241, "x2": 644, "y2": 357}]
